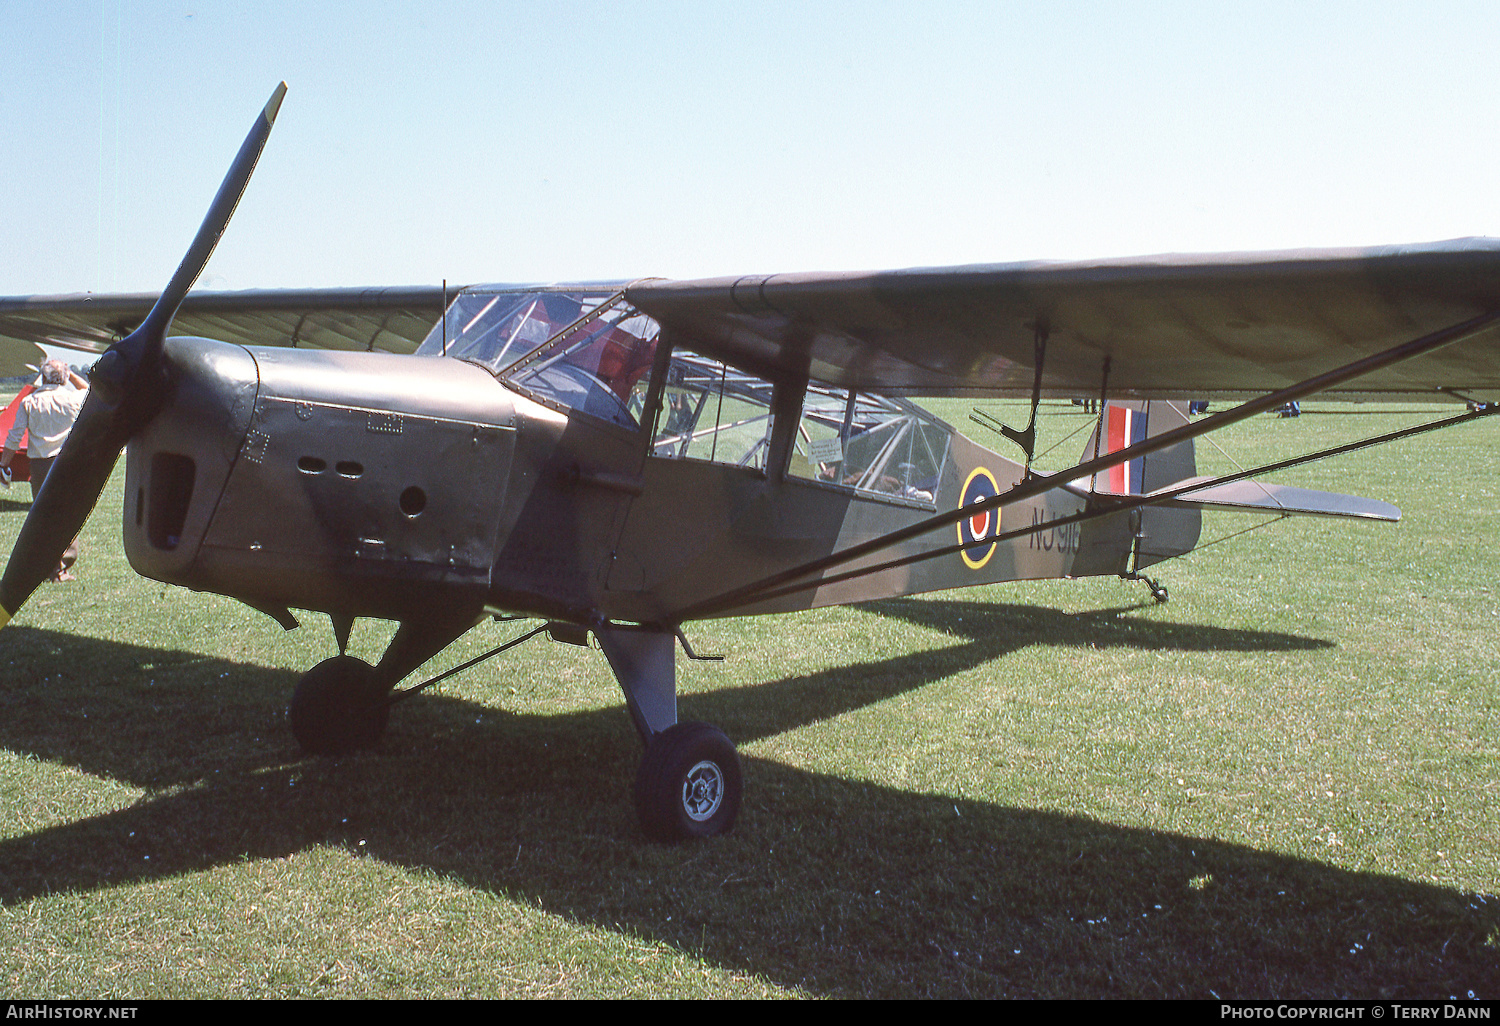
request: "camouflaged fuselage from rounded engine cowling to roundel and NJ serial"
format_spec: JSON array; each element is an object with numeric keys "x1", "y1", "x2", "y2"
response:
[{"x1": 125, "y1": 309, "x2": 1152, "y2": 624}]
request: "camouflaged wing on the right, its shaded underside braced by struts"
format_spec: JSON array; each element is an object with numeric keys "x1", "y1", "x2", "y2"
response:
[{"x1": 629, "y1": 239, "x2": 1500, "y2": 401}]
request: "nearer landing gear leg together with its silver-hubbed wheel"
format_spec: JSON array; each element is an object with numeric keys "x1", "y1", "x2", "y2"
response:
[{"x1": 594, "y1": 627, "x2": 743, "y2": 843}]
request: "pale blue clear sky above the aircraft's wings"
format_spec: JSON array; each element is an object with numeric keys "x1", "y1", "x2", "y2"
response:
[{"x1": 0, "y1": 0, "x2": 1500, "y2": 296}]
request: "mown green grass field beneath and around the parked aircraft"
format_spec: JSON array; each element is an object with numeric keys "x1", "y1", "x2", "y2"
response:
[{"x1": 0, "y1": 404, "x2": 1500, "y2": 999}]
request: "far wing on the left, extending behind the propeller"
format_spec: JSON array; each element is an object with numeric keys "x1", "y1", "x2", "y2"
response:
[{"x1": 0, "y1": 287, "x2": 458, "y2": 377}]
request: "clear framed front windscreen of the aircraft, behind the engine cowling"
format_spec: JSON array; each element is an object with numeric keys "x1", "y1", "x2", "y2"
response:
[{"x1": 417, "y1": 290, "x2": 660, "y2": 428}]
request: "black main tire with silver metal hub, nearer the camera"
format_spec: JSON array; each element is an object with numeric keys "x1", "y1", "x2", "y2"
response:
[{"x1": 636, "y1": 723, "x2": 743, "y2": 843}]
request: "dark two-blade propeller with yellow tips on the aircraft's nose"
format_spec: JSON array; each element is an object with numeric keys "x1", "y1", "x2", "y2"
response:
[{"x1": 0, "y1": 83, "x2": 287, "y2": 627}]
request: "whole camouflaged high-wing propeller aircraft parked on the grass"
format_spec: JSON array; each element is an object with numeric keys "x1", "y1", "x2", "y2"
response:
[{"x1": 0, "y1": 86, "x2": 1500, "y2": 840}]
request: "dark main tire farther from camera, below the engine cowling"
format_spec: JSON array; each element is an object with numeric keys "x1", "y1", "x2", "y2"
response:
[{"x1": 287, "y1": 656, "x2": 390, "y2": 755}]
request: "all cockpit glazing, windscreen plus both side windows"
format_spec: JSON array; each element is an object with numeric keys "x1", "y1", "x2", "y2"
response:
[{"x1": 417, "y1": 285, "x2": 953, "y2": 506}]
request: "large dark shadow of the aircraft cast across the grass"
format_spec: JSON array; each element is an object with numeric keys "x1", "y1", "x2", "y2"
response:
[{"x1": 0, "y1": 602, "x2": 1500, "y2": 998}]
